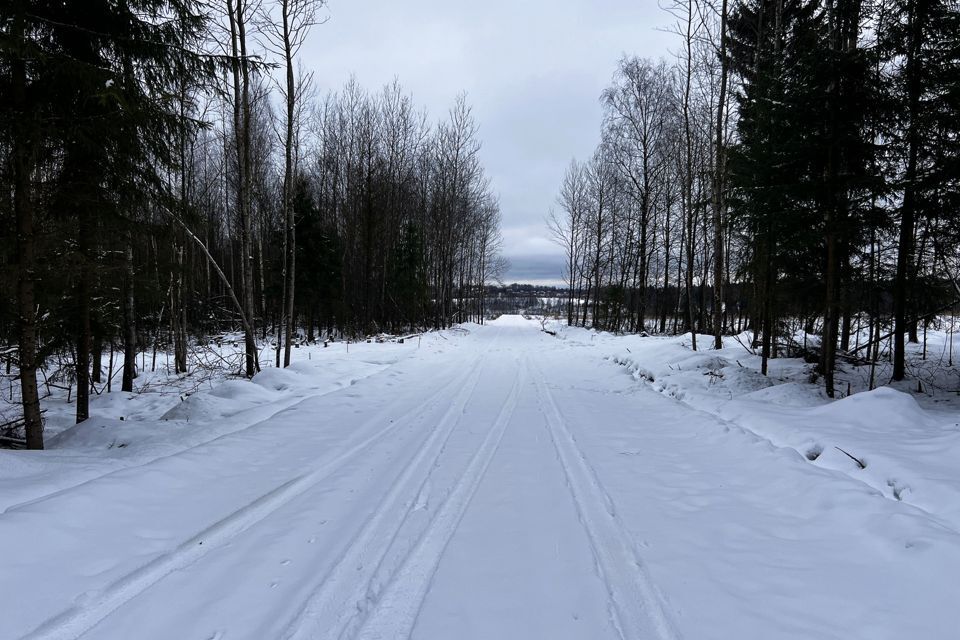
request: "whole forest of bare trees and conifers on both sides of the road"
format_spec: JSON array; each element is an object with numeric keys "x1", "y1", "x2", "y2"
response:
[{"x1": 0, "y1": 0, "x2": 960, "y2": 448}]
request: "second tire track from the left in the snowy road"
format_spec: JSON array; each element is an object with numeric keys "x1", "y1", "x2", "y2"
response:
[{"x1": 282, "y1": 350, "x2": 510, "y2": 640}]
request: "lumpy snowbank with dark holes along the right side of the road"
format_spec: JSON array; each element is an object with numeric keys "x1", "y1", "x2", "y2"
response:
[{"x1": 551, "y1": 324, "x2": 960, "y2": 530}]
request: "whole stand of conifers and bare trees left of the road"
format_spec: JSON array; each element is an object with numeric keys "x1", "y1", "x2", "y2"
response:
[{"x1": 0, "y1": 0, "x2": 504, "y2": 448}]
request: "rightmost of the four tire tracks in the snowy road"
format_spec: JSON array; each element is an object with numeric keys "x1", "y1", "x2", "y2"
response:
[{"x1": 536, "y1": 360, "x2": 680, "y2": 640}]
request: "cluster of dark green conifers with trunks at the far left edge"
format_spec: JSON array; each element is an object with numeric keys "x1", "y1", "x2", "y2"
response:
[{"x1": 0, "y1": 0, "x2": 214, "y2": 447}]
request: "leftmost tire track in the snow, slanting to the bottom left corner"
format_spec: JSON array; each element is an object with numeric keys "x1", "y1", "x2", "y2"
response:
[{"x1": 23, "y1": 356, "x2": 482, "y2": 640}]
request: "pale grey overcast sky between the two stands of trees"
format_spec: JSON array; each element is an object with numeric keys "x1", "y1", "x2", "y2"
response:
[{"x1": 301, "y1": 0, "x2": 673, "y2": 282}]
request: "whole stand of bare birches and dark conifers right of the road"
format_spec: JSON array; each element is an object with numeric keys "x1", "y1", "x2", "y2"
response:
[{"x1": 549, "y1": 0, "x2": 960, "y2": 396}]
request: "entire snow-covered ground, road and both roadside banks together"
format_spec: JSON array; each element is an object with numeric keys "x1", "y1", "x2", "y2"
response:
[{"x1": 0, "y1": 316, "x2": 960, "y2": 640}]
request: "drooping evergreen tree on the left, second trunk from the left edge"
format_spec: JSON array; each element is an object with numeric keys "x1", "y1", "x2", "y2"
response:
[{"x1": 45, "y1": 0, "x2": 212, "y2": 422}]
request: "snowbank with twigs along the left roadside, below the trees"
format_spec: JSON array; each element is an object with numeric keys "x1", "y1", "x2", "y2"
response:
[{"x1": 0, "y1": 332, "x2": 454, "y2": 512}]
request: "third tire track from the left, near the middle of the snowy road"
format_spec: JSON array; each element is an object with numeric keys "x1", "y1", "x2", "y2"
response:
[{"x1": 348, "y1": 361, "x2": 527, "y2": 640}]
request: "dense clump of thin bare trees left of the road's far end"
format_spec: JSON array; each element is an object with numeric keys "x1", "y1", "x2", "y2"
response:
[{"x1": 310, "y1": 82, "x2": 505, "y2": 331}]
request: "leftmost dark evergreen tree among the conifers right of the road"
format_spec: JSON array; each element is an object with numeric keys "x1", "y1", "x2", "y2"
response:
[{"x1": 729, "y1": 0, "x2": 824, "y2": 373}]
